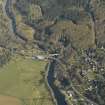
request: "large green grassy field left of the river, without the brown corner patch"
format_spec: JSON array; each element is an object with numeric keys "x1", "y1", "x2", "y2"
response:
[{"x1": 0, "y1": 56, "x2": 53, "y2": 105}]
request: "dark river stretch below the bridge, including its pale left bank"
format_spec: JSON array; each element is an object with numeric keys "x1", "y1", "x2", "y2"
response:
[{"x1": 45, "y1": 61, "x2": 67, "y2": 105}]
